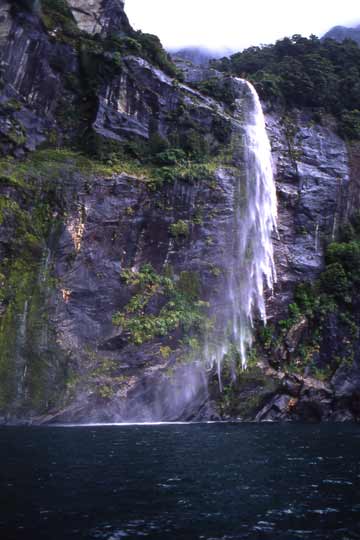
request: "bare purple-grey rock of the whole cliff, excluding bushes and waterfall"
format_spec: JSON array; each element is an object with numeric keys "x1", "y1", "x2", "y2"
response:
[{"x1": 0, "y1": 0, "x2": 360, "y2": 422}]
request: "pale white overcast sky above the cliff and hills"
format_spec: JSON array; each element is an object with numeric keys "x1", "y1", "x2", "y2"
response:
[{"x1": 125, "y1": 0, "x2": 360, "y2": 51}]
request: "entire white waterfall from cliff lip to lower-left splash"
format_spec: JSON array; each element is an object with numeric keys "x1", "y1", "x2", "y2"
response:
[{"x1": 205, "y1": 79, "x2": 277, "y2": 385}]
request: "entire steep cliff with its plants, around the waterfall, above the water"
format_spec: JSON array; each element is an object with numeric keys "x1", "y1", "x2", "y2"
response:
[{"x1": 0, "y1": 0, "x2": 360, "y2": 422}]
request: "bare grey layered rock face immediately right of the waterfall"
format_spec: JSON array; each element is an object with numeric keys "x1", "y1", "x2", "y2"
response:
[{"x1": 267, "y1": 111, "x2": 350, "y2": 313}]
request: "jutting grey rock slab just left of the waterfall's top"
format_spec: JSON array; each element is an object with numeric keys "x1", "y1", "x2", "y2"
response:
[{"x1": 93, "y1": 56, "x2": 232, "y2": 145}]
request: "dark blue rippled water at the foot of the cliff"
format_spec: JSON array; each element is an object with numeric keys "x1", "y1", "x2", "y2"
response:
[{"x1": 0, "y1": 424, "x2": 360, "y2": 540}]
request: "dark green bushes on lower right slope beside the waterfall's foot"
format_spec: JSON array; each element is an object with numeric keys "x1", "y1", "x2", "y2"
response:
[{"x1": 259, "y1": 214, "x2": 360, "y2": 379}]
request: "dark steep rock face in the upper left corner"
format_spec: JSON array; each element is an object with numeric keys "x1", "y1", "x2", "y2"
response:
[{"x1": 0, "y1": 3, "x2": 77, "y2": 155}]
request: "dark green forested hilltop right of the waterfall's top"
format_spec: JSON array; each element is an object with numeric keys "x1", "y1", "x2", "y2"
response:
[{"x1": 213, "y1": 35, "x2": 360, "y2": 138}]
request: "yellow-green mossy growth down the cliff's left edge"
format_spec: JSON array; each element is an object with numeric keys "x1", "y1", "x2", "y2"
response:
[{"x1": 0, "y1": 149, "x2": 126, "y2": 414}]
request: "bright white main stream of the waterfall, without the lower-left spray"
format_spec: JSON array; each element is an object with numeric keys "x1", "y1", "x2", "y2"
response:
[{"x1": 230, "y1": 82, "x2": 277, "y2": 367}]
